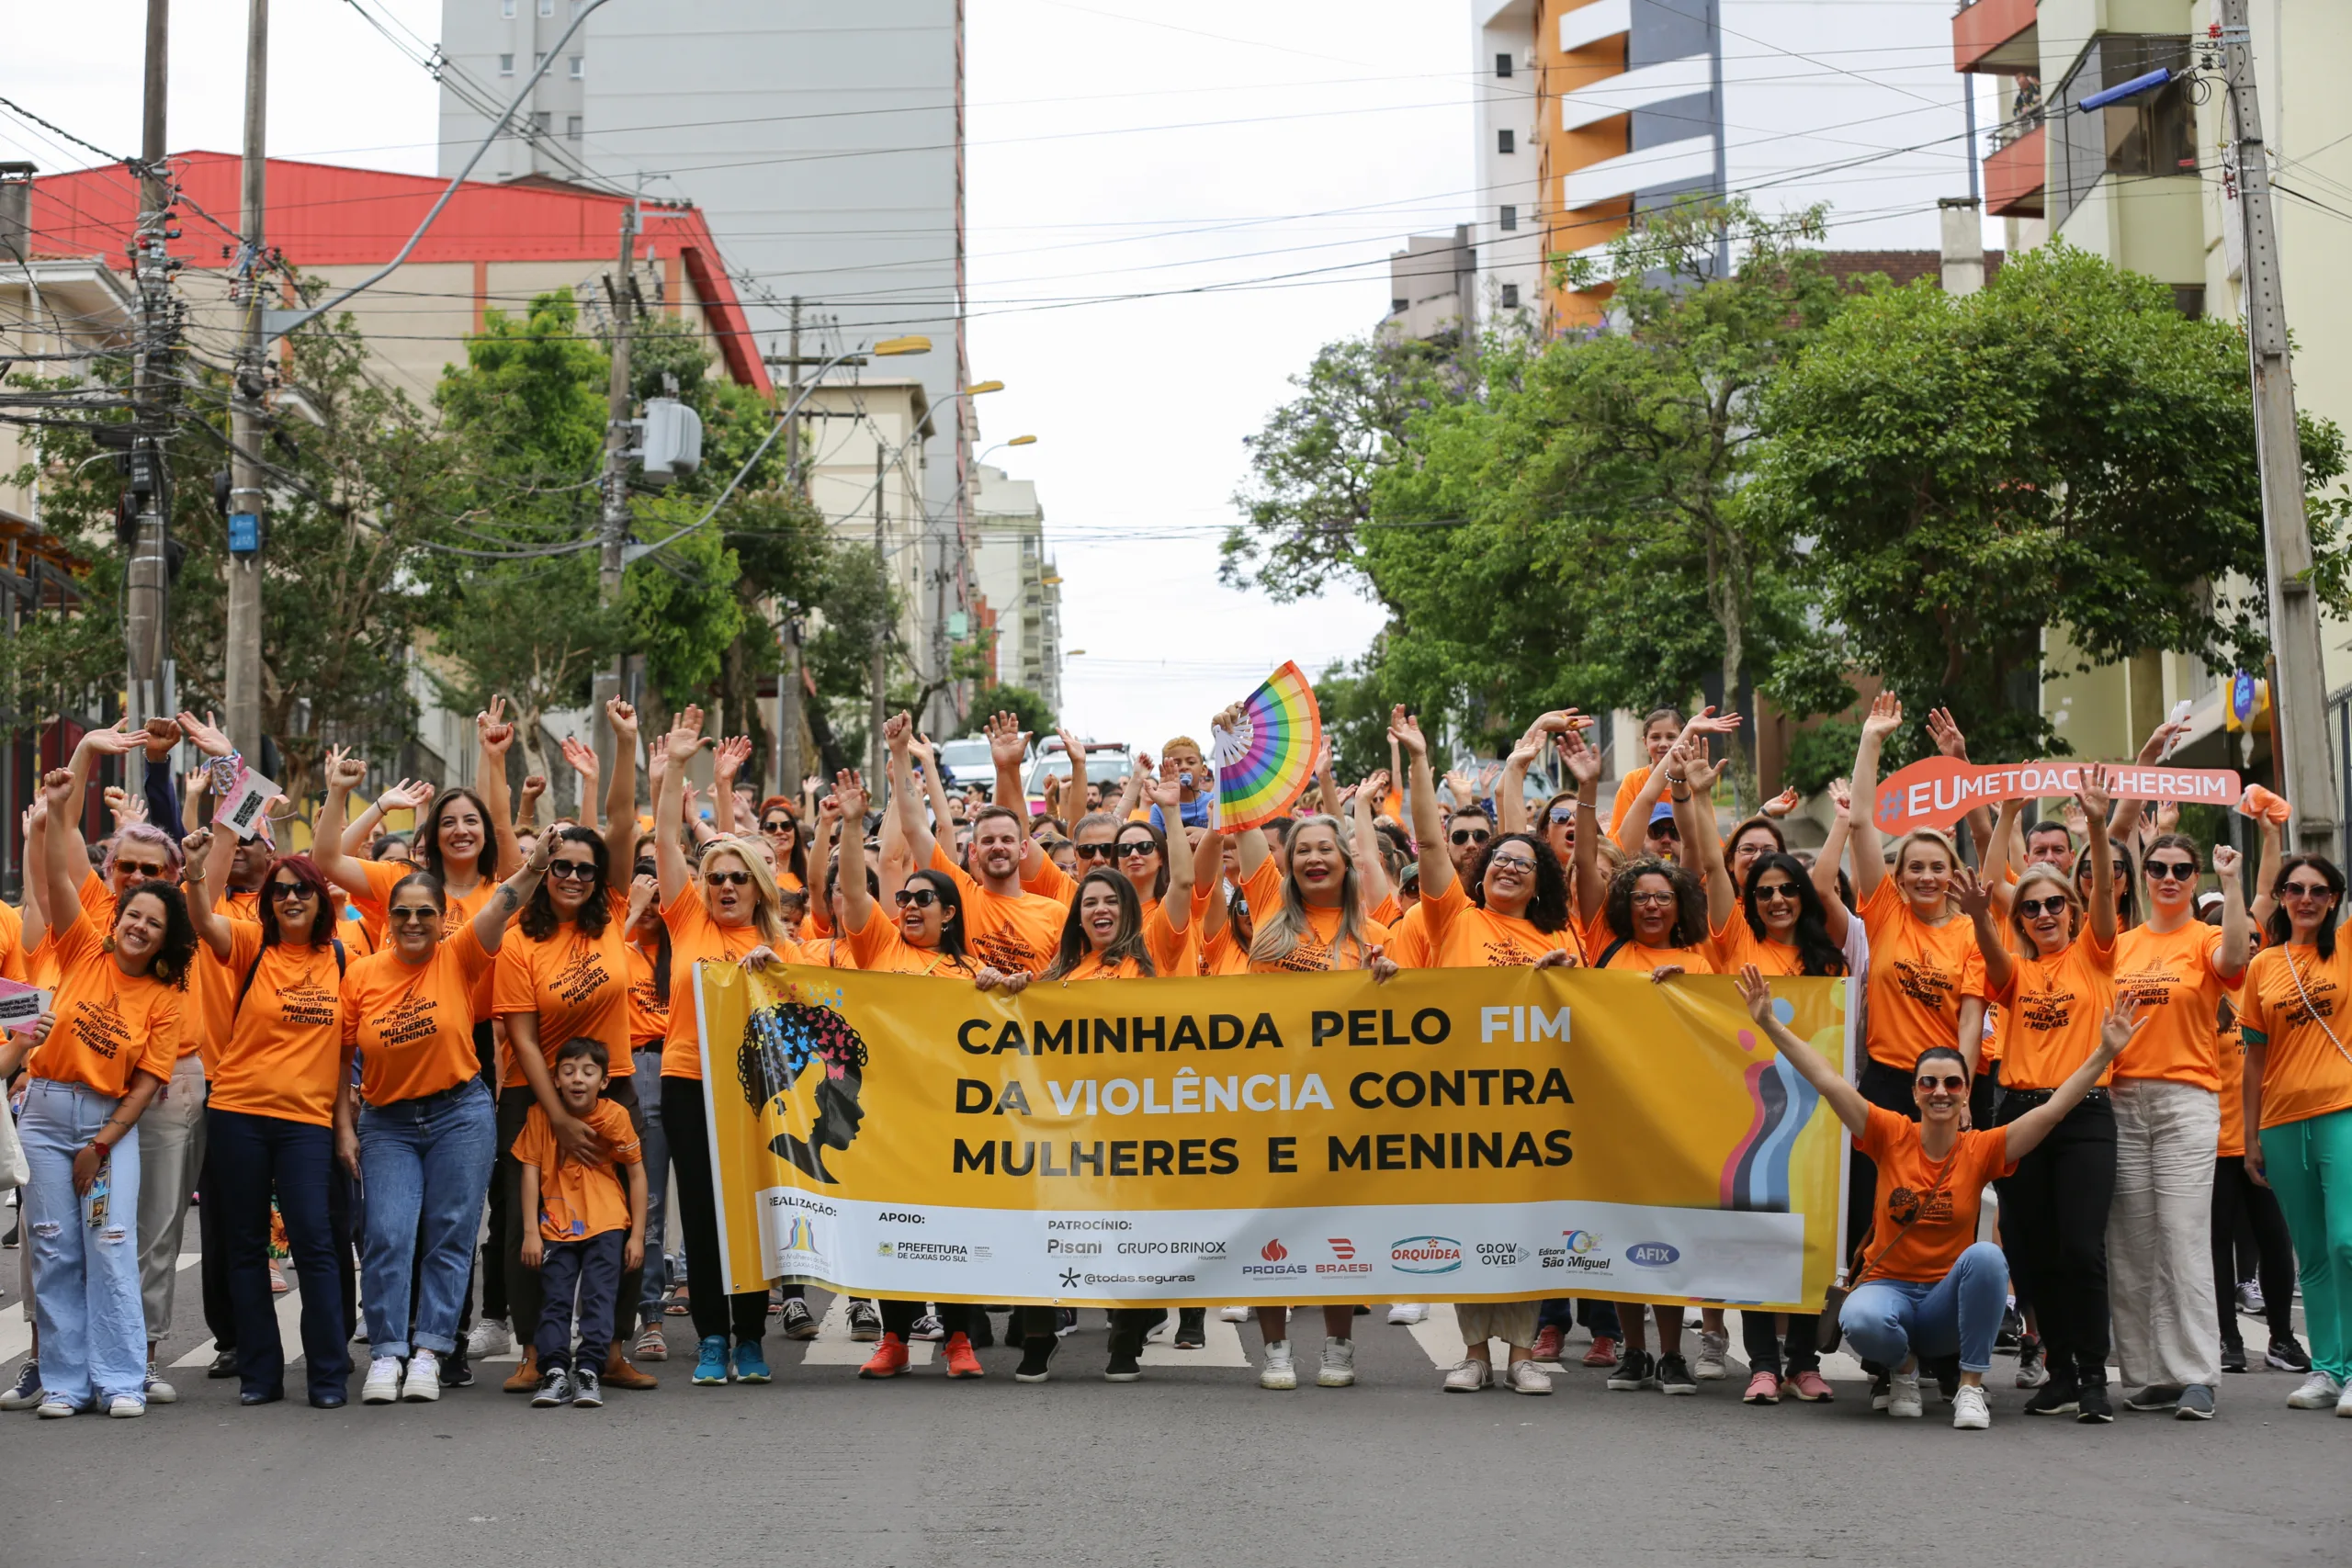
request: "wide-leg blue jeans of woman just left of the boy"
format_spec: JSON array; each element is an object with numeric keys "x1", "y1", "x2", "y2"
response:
[{"x1": 360, "y1": 1079, "x2": 499, "y2": 1359}]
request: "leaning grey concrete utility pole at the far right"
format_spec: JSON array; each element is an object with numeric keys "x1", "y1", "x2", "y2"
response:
[{"x1": 2211, "y1": 0, "x2": 2343, "y2": 861}]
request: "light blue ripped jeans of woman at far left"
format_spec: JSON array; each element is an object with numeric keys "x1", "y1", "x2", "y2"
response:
[{"x1": 17, "y1": 1079, "x2": 146, "y2": 1411}]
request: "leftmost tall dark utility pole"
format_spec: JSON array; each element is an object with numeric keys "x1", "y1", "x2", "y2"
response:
[{"x1": 122, "y1": 0, "x2": 176, "y2": 783}]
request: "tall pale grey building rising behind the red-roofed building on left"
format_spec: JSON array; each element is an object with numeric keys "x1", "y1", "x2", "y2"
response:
[{"x1": 440, "y1": 0, "x2": 974, "y2": 733}]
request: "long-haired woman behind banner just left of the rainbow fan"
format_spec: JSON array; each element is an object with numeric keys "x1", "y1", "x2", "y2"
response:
[{"x1": 976, "y1": 778, "x2": 1226, "y2": 1382}]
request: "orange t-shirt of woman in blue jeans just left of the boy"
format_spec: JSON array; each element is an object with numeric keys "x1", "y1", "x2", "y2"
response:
[{"x1": 344, "y1": 921, "x2": 492, "y2": 1105}]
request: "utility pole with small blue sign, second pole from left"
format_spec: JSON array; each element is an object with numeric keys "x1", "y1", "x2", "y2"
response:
[{"x1": 223, "y1": 0, "x2": 270, "y2": 757}]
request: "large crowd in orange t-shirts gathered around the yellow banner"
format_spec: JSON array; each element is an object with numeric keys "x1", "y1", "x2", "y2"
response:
[{"x1": 0, "y1": 696, "x2": 2352, "y2": 1429}]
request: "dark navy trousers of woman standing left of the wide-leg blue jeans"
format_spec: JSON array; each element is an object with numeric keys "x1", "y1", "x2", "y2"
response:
[{"x1": 205, "y1": 1110, "x2": 350, "y2": 1394}]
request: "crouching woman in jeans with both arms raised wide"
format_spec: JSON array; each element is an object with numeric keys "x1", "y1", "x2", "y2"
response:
[{"x1": 1738, "y1": 964, "x2": 2145, "y2": 1432}]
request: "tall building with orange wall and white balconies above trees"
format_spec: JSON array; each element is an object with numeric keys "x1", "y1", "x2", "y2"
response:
[{"x1": 1470, "y1": 0, "x2": 1971, "y2": 332}]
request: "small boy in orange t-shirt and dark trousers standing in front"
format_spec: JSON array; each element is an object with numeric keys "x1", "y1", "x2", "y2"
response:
[{"x1": 515, "y1": 1034, "x2": 644, "y2": 1411}]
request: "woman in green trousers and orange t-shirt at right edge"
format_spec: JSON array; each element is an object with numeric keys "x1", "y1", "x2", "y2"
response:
[{"x1": 2239, "y1": 853, "x2": 2352, "y2": 1416}]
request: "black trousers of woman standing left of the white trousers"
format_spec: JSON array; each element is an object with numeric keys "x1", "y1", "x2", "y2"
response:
[{"x1": 1995, "y1": 1090, "x2": 2114, "y2": 1382}]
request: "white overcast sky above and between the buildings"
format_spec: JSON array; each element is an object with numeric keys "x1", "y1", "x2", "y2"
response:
[{"x1": 0, "y1": 0, "x2": 1984, "y2": 748}]
